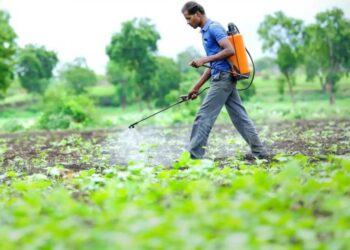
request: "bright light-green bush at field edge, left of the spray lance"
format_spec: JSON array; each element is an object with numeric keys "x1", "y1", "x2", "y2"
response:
[{"x1": 38, "y1": 88, "x2": 95, "y2": 130}]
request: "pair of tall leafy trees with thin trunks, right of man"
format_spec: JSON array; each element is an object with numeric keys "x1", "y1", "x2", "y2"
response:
[{"x1": 258, "y1": 8, "x2": 350, "y2": 104}]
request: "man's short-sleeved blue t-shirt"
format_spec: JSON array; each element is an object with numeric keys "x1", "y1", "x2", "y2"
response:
[{"x1": 201, "y1": 19, "x2": 231, "y2": 76}]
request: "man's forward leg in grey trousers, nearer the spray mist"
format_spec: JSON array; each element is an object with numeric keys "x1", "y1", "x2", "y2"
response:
[{"x1": 189, "y1": 77, "x2": 232, "y2": 159}]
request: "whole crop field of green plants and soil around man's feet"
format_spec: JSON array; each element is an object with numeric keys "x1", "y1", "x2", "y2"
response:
[{"x1": 0, "y1": 119, "x2": 350, "y2": 249}]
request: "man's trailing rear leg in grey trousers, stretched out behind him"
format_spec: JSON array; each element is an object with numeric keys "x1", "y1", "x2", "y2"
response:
[{"x1": 225, "y1": 88, "x2": 267, "y2": 157}]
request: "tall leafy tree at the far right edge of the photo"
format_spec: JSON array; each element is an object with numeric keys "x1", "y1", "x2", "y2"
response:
[{"x1": 304, "y1": 8, "x2": 350, "y2": 104}]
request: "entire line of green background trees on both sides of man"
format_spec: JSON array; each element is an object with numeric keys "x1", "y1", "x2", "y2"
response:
[{"x1": 0, "y1": 8, "x2": 350, "y2": 107}]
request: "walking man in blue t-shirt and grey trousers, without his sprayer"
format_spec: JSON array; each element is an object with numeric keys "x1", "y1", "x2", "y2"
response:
[{"x1": 182, "y1": 1, "x2": 268, "y2": 159}]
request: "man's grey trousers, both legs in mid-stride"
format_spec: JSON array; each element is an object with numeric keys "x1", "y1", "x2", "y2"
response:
[{"x1": 189, "y1": 72, "x2": 267, "y2": 159}]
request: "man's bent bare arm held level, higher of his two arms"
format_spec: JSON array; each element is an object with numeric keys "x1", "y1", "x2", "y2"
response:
[{"x1": 190, "y1": 37, "x2": 235, "y2": 68}]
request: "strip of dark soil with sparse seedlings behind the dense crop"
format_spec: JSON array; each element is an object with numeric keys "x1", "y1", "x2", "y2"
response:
[{"x1": 0, "y1": 119, "x2": 350, "y2": 173}]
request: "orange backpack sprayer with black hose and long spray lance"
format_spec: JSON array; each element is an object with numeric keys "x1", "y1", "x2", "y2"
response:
[{"x1": 129, "y1": 23, "x2": 255, "y2": 128}]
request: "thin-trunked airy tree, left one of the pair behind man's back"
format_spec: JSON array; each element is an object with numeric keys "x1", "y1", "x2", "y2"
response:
[{"x1": 258, "y1": 11, "x2": 304, "y2": 103}]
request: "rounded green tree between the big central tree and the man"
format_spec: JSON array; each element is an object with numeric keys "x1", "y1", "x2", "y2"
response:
[{"x1": 152, "y1": 57, "x2": 181, "y2": 106}]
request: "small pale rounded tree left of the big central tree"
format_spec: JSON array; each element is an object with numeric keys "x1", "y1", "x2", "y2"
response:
[{"x1": 60, "y1": 58, "x2": 97, "y2": 94}]
